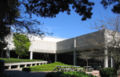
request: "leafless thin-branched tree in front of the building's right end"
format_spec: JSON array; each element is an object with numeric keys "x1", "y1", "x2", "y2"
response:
[{"x1": 94, "y1": 15, "x2": 120, "y2": 74}]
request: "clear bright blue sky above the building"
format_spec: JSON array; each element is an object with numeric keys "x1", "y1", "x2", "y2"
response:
[{"x1": 23, "y1": 0, "x2": 116, "y2": 38}]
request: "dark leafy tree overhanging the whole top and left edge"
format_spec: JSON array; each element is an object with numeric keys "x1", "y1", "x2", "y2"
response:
[{"x1": 0, "y1": 0, "x2": 120, "y2": 56}]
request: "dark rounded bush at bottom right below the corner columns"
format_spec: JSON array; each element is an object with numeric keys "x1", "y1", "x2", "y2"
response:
[{"x1": 100, "y1": 68, "x2": 116, "y2": 77}]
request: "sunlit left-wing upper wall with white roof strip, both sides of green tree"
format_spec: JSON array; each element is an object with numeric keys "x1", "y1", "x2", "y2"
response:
[{"x1": 5, "y1": 34, "x2": 63, "y2": 54}]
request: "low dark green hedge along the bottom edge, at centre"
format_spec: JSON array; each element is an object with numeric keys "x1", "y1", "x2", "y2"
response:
[{"x1": 46, "y1": 72, "x2": 94, "y2": 77}]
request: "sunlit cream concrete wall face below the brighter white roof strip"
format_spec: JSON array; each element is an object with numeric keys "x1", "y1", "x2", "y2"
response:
[{"x1": 29, "y1": 40, "x2": 56, "y2": 53}]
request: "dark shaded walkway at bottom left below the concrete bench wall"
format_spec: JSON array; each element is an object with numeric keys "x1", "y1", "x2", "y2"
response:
[{"x1": 5, "y1": 70, "x2": 48, "y2": 77}]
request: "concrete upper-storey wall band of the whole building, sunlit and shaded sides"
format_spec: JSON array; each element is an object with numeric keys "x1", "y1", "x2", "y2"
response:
[{"x1": 6, "y1": 30, "x2": 120, "y2": 54}]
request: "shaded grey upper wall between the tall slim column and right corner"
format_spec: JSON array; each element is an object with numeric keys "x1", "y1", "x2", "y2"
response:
[{"x1": 76, "y1": 30, "x2": 105, "y2": 50}]
